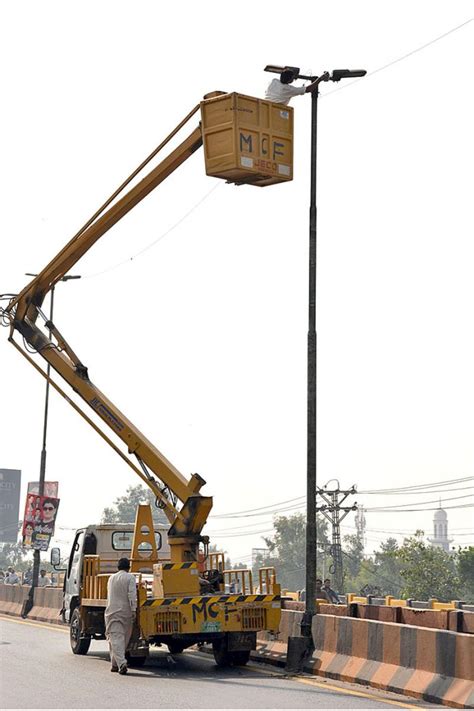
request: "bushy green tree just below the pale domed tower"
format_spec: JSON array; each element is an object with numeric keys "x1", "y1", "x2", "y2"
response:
[{"x1": 396, "y1": 531, "x2": 461, "y2": 601}]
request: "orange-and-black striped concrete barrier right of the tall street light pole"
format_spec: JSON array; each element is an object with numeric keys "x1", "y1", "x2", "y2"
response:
[{"x1": 305, "y1": 615, "x2": 474, "y2": 708}]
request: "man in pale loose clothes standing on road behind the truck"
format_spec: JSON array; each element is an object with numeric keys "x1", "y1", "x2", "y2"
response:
[{"x1": 105, "y1": 558, "x2": 137, "y2": 674}]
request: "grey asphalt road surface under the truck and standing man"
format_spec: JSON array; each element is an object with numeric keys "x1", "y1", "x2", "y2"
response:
[{"x1": 0, "y1": 616, "x2": 432, "y2": 709}]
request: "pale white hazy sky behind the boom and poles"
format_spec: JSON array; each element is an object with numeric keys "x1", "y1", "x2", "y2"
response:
[{"x1": 0, "y1": 0, "x2": 474, "y2": 562}]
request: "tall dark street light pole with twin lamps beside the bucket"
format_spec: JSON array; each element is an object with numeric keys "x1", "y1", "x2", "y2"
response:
[{"x1": 265, "y1": 64, "x2": 367, "y2": 670}]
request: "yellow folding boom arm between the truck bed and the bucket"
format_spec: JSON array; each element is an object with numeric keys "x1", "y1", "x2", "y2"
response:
[{"x1": 5, "y1": 100, "x2": 217, "y2": 562}]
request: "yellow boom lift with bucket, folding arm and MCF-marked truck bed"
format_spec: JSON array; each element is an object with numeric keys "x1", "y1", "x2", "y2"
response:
[{"x1": 3, "y1": 92, "x2": 293, "y2": 663}]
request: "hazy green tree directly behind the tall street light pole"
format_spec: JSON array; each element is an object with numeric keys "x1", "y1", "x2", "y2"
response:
[{"x1": 259, "y1": 514, "x2": 329, "y2": 591}]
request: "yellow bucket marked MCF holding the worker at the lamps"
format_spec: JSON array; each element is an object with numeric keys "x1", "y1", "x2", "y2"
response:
[{"x1": 201, "y1": 93, "x2": 293, "y2": 186}]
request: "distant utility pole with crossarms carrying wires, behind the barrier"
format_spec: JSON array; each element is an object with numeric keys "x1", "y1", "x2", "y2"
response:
[{"x1": 316, "y1": 479, "x2": 357, "y2": 594}]
